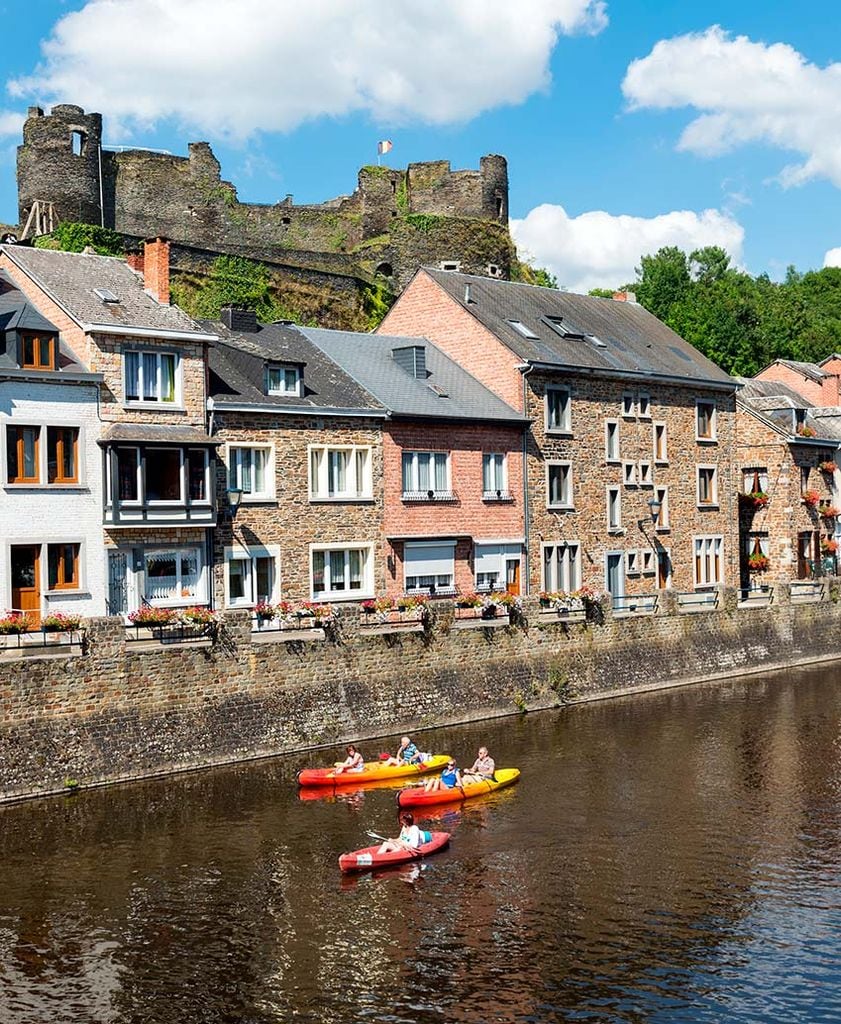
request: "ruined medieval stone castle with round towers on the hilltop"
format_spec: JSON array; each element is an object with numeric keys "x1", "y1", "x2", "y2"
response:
[{"x1": 17, "y1": 103, "x2": 513, "y2": 292}]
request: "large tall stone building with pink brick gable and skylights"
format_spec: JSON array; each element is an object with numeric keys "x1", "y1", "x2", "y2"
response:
[{"x1": 380, "y1": 268, "x2": 739, "y2": 603}]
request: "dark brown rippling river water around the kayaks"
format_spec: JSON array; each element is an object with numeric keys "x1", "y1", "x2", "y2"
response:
[{"x1": 0, "y1": 669, "x2": 841, "y2": 1024}]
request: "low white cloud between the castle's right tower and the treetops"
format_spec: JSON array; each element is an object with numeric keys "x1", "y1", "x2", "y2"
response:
[{"x1": 511, "y1": 204, "x2": 745, "y2": 292}]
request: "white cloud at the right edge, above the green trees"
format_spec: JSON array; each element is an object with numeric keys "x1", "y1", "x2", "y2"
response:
[{"x1": 622, "y1": 26, "x2": 841, "y2": 187}]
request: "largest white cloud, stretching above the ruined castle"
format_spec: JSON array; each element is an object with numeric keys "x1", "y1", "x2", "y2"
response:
[{"x1": 7, "y1": 0, "x2": 607, "y2": 138}]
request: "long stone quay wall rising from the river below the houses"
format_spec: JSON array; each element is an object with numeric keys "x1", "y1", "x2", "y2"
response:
[{"x1": 0, "y1": 579, "x2": 841, "y2": 800}]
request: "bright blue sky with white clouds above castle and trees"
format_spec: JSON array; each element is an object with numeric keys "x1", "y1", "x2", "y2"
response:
[{"x1": 0, "y1": 0, "x2": 841, "y2": 290}]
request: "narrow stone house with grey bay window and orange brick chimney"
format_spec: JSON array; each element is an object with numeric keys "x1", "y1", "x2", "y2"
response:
[{"x1": 0, "y1": 240, "x2": 216, "y2": 613}]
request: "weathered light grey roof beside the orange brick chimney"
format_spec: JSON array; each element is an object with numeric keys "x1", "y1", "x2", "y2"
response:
[{"x1": 0, "y1": 246, "x2": 209, "y2": 335}]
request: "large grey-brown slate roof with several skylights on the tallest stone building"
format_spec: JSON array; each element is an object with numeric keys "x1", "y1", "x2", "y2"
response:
[{"x1": 423, "y1": 267, "x2": 734, "y2": 388}]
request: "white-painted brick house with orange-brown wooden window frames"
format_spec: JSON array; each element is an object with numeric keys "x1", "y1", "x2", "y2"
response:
[{"x1": 0, "y1": 270, "x2": 106, "y2": 623}]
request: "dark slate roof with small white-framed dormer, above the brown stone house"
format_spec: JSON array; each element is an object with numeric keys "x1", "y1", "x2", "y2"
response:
[{"x1": 202, "y1": 321, "x2": 385, "y2": 416}]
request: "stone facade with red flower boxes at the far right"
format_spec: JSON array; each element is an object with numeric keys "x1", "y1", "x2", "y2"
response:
[{"x1": 734, "y1": 402, "x2": 841, "y2": 587}]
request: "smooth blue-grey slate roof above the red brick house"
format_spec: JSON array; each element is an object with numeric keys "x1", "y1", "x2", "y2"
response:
[{"x1": 299, "y1": 328, "x2": 527, "y2": 424}]
